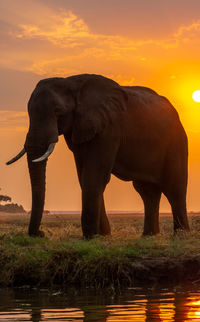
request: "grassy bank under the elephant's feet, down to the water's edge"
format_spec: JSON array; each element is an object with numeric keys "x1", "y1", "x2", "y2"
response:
[{"x1": 0, "y1": 214, "x2": 200, "y2": 288}]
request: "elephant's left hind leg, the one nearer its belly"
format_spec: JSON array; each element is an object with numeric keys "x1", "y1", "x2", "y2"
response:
[{"x1": 133, "y1": 181, "x2": 161, "y2": 235}]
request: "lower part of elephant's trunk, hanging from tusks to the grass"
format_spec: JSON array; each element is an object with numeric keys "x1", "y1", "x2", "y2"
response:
[{"x1": 27, "y1": 149, "x2": 47, "y2": 236}]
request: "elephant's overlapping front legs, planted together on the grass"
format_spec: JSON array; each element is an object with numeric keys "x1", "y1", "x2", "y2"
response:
[{"x1": 70, "y1": 136, "x2": 118, "y2": 238}]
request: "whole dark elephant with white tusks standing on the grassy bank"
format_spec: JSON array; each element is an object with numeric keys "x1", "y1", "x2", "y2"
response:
[{"x1": 7, "y1": 74, "x2": 189, "y2": 239}]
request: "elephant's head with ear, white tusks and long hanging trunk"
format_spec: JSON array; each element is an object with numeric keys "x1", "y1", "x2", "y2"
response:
[{"x1": 7, "y1": 74, "x2": 127, "y2": 235}]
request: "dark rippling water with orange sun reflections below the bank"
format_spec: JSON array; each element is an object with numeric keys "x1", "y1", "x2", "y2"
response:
[{"x1": 0, "y1": 287, "x2": 200, "y2": 322}]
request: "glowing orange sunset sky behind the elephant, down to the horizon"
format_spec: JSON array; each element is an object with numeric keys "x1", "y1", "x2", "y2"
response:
[{"x1": 0, "y1": 0, "x2": 200, "y2": 211}]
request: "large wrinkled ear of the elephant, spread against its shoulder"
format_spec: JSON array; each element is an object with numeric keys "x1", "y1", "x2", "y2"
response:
[{"x1": 72, "y1": 75, "x2": 128, "y2": 144}]
